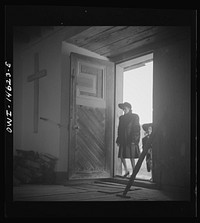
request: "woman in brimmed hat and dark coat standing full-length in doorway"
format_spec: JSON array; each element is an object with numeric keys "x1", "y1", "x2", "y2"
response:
[{"x1": 116, "y1": 102, "x2": 140, "y2": 177}]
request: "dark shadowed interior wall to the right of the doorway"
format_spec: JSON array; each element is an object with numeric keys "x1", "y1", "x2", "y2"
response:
[{"x1": 153, "y1": 28, "x2": 191, "y2": 196}]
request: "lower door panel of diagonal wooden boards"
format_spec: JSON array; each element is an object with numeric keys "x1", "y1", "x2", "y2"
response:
[{"x1": 75, "y1": 106, "x2": 105, "y2": 172}]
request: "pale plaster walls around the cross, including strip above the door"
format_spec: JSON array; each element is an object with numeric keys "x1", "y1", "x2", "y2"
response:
[{"x1": 14, "y1": 26, "x2": 108, "y2": 172}]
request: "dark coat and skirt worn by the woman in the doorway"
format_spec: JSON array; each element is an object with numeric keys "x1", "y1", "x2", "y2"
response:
[{"x1": 116, "y1": 112, "x2": 140, "y2": 158}]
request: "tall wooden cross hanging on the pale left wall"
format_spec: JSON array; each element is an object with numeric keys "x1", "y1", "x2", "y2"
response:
[{"x1": 27, "y1": 53, "x2": 47, "y2": 133}]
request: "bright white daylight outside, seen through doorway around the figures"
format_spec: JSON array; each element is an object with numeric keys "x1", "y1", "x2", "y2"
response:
[{"x1": 123, "y1": 61, "x2": 153, "y2": 180}]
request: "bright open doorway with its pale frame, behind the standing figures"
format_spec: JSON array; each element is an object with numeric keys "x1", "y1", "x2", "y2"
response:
[{"x1": 116, "y1": 53, "x2": 153, "y2": 181}]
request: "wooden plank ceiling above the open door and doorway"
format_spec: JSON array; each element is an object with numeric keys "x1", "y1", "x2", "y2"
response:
[{"x1": 67, "y1": 26, "x2": 182, "y2": 58}]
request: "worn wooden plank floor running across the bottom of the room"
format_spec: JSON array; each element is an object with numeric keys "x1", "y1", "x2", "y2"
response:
[{"x1": 13, "y1": 180, "x2": 184, "y2": 201}]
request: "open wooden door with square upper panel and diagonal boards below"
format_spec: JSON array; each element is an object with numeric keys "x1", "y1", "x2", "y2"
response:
[{"x1": 69, "y1": 53, "x2": 114, "y2": 179}]
